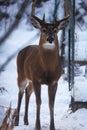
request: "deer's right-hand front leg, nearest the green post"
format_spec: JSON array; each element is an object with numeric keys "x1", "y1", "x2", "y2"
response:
[{"x1": 48, "y1": 83, "x2": 57, "y2": 130}]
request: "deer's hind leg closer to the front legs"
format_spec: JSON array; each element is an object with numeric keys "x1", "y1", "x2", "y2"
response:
[{"x1": 24, "y1": 81, "x2": 33, "y2": 125}]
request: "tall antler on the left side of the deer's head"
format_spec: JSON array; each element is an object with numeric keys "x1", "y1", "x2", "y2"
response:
[{"x1": 31, "y1": 0, "x2": 45, "y2": 25}]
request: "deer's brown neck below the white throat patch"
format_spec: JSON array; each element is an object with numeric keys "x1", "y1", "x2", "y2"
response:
[{"x1": 39, "y1": 39, "x2": 59, "y2": 71}]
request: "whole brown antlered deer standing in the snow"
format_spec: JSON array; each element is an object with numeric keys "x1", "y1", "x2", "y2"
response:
[{"x1": 15, "y1": 0, "x2": 70, "y2": 130}]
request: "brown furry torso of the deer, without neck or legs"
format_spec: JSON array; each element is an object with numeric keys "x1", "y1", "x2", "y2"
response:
[{"x1": 17, "y1": 46, "x2": 61, "y2": 87}]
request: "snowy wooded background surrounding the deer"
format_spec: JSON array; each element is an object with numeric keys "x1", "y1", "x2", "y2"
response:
[{"x1": 0, "y1": 0, "x2": 87, "y2": 130}]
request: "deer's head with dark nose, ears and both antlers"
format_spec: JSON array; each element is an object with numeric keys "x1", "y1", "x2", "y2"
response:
[{"x1": 31, "y1": 1, "x2": 71, "y2": 48}]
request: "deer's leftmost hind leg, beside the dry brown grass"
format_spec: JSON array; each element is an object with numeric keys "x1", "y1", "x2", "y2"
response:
[{"x1": 15, "y1": 77, "x2": 27, "y2": 126}]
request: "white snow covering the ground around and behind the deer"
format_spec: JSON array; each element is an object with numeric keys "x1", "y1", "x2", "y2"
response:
[{"x1": 0, "y1": 0, "x2": 87, "y2": 127}]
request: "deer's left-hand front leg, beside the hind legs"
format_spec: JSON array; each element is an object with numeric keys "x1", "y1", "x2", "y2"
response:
[{"x1": 33, "y1": 81, "x2": 41, "y2": 130}]
